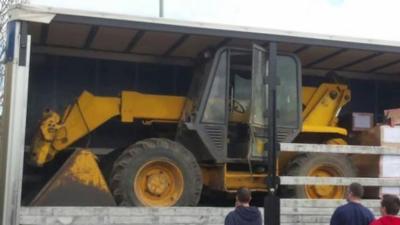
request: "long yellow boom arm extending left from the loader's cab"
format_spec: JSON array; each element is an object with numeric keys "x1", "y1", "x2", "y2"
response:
[{"x1": 31, "y1": 91, "x2": 185, "y2": 166}]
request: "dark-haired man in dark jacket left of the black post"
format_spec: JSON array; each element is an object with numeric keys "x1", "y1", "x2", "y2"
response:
[{"x1": 225, "y1": 188, "x2": 262, "y2": 225}]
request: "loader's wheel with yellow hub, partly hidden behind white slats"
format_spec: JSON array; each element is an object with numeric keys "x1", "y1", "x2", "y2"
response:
[{"x1": 286, "y1": 154, "x2": 356, "y2": 199}]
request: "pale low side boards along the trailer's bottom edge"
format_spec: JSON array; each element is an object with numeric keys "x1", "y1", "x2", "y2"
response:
[{"x1": 20, "y1": 199, "x2": 379, "y2": 225}]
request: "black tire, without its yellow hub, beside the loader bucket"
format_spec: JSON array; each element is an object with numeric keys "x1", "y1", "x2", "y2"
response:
[{"x1": 110, "y1": 138, "x2": 203, "y2": 206}]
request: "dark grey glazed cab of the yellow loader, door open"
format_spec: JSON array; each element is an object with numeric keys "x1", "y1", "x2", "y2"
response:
[{"x1": 177, "y1": 45, "x2": 302, "y2": 163}]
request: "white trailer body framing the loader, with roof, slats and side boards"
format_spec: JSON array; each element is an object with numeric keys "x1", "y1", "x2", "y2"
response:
[{"x1": 0, "y1": 4, "x2": 400, "y2": 225}]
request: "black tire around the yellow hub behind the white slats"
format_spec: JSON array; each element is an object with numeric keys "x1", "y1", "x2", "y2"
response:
[{"x1": 283, "y1": 154, "x2": 357, "y2": 198}]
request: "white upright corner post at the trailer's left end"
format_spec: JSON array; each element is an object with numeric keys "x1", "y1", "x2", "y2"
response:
[{"x1": 0, "y1": 21, "x2": 31, "y2": 225}]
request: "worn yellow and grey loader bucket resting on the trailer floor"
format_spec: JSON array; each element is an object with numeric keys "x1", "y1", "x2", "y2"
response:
[{"x1": 31, "y1": 149, "x2": 116, "y2": 206}]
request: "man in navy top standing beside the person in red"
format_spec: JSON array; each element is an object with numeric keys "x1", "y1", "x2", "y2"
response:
[{"x1": 331, "y1": 183, "x2": 374, "y2": 225}]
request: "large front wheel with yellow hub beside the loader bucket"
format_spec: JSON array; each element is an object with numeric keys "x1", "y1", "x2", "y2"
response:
[{"x1": 110, "y1": 138, "x2": 203, "y2": 207}]
